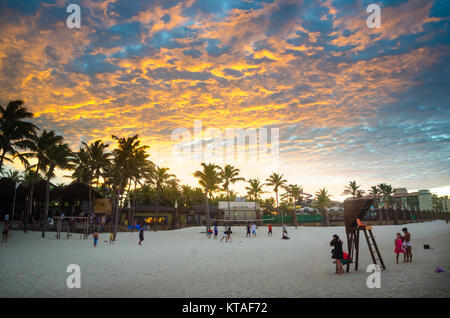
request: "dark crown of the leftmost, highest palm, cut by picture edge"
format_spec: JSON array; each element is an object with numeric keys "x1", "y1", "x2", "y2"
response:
[{"x1": 0, "y1": 100, "x2": 39, "y2": 172}]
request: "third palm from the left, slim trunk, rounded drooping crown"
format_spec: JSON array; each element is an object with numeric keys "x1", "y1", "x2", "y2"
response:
[{"x1": 42, "y1": 140, "x2": 74, "y2": 237}]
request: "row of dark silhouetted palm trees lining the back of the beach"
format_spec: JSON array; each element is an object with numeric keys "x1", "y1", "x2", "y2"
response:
[{"x1": 5, "y1": 101, "x2": 398, "y2": 239}]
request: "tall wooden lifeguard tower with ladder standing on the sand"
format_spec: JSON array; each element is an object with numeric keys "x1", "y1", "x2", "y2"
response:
[{"x1": 344, "y1": 198, "x2": 386, "y2": 272}]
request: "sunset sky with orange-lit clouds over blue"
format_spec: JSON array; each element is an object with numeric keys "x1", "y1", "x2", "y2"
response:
[{"x1": 0, "y1": 0, "x2": 450, "y2": 200}]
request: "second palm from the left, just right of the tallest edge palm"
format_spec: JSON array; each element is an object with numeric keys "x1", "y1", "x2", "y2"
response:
[{"x1": 20, "y1": 130, "x2": 63, "y2": 235}]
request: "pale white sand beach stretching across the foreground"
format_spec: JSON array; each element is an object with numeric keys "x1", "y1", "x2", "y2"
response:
[{"x1": 0, "y1": 221, "x2": 450, "y2": 298}]
